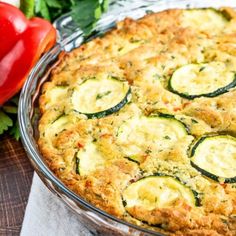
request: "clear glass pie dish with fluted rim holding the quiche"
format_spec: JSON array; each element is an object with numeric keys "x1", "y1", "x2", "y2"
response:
[{"x1": 19, "y1": 0, "x2": 236, "y2": 235}]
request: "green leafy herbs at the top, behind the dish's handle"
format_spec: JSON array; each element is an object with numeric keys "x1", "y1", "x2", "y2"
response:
[{"x1": 20, "y1": 0, "x2": 109, "y2": 34}]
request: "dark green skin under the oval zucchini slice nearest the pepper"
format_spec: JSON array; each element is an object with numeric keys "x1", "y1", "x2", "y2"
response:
[{"x1": 74, "y1": 88, "x2": 131, "y2": 119}]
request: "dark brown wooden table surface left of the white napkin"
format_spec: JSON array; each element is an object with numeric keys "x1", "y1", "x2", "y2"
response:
[{"x1": 0, "y1": 135, "x2": 33, "y2": 236}]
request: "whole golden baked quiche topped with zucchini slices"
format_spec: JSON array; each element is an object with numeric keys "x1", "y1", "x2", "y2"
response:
[{"x1": 38, "y1": 7, "x2": 236, "y2": 236}]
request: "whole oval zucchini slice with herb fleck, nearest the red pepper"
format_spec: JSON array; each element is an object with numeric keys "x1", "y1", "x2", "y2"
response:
[{"x1": 72, "y1": 77, "x2": 131, "y2": 118}]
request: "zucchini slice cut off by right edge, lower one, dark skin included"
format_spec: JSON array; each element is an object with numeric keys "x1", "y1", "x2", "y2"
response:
[{"x1": 191, "y1": 135, "x2": 236, "y2": 183}]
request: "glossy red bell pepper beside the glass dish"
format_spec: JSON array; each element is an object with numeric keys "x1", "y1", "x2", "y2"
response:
[{"x1": 0, "y1": 2, "x2": 56, "y2": 105}]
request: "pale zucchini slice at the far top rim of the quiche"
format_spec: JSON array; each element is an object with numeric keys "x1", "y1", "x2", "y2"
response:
[{"x1": 182, "y1": 8, "x2": 228, "y2": 34}]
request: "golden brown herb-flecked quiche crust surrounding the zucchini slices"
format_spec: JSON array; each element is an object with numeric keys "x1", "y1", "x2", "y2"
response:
[{"x1": 38, "y1": 8, "x2": 236, "y2": 236}]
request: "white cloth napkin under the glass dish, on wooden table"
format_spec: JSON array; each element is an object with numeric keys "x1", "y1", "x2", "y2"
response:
[{"x1": 21, "y1": 173, "x2": 92, "y2": 236}]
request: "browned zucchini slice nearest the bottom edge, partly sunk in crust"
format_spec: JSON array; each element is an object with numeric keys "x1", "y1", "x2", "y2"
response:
[{"x1": 122, "y1": 176, "x2": 198, "y2": 212}]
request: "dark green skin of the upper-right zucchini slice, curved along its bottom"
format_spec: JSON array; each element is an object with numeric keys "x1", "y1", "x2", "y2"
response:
[{"x1": 168, "y1": 75, "x2": 236, "y2": 100}]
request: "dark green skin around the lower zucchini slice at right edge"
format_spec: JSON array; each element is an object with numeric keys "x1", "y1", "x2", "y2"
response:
[{"x1": 190, "y1": 135, "x2": 236, "y2": 183}]
